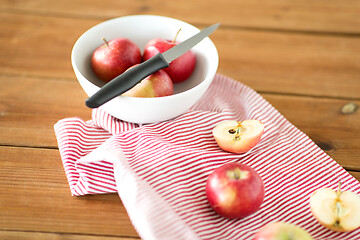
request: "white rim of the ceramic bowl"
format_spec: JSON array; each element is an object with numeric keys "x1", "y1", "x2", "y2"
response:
[{"x1": 71, "y1": 14, "x2": 219, "y2": 102}]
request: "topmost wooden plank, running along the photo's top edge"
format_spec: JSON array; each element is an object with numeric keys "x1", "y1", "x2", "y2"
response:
[{"x1": 0, "y1": 0, "x2": 360, "y2": 33}]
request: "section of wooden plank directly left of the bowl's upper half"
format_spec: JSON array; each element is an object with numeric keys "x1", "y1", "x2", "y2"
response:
[{"x1": 0, "y1": 13, "x2": 100, "y2": 80}]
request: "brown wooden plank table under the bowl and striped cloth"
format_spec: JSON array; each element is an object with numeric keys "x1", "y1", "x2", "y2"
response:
[{"x1": 0, "y1": 0, "x2": 360, "y2": 240}]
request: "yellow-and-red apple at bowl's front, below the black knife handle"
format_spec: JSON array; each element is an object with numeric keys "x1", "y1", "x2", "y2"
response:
[{"x1": 122, "y1": 64, "x2": 174, "y2": 98}]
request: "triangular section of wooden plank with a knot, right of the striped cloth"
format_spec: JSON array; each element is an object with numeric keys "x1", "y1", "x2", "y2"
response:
[{"x1": 263, "y1": 94, "x2": 360, "y2": 171}]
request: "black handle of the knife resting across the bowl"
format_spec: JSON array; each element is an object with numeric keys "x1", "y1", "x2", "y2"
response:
[{"x1": 85, "y1": 53, "x2": 169, "y2": 108}]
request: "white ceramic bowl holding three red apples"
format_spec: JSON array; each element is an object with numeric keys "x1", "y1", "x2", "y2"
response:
[{"x1": 71, "y1": 15, "x2": 219, "y2": 123}]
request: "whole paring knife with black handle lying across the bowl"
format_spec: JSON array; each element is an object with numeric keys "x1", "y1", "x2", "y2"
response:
[{"x1": 85, "y1": 23, "x2": 220, "y2": 108}]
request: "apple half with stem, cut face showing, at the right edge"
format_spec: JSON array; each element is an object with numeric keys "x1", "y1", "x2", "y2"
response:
[{"x1": 310, "y1": 183, "x2": 360, "y2": 232}]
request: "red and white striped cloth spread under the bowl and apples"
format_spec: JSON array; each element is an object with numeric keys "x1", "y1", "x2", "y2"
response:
[{"x1": 55, "y1": 74, "x2": 360, "y2": 240}]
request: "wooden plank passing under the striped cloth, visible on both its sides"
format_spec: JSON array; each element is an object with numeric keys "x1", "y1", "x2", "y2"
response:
[{"x1": 0, "y1": 77, "x2": 360, "y2": 170}]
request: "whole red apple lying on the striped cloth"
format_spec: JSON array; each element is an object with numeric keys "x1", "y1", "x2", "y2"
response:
[{"x1": 205, "y1": 163, "x2": 265, "y2": 219}]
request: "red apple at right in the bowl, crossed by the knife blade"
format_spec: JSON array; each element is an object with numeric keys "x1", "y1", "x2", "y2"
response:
[{"x1": 143, "y1": 38, "x2": 196, "y2": 83}]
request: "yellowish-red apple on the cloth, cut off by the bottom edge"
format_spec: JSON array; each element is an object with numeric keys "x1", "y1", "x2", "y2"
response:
[{"x1": 253, "y1": 222, "x2": 313, "y2": 240}]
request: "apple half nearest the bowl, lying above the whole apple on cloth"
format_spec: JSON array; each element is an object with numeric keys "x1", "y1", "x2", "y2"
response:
[{"x1": 213, "y1": 120, "x2": 264, "y2": 153}]
